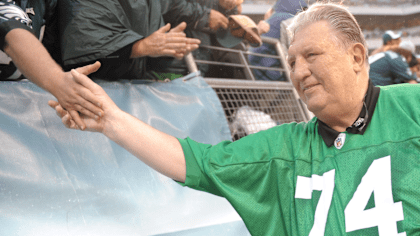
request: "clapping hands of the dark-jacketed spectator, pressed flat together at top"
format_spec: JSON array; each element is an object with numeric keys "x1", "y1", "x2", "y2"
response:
[{"x1": 131, "y1": 22, "x2": 200, "y2": 59}]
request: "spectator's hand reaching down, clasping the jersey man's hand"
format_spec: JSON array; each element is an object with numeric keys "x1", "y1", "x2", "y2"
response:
[{"x1": 52, "y1": 62, "x2": 103, "y2": 129}]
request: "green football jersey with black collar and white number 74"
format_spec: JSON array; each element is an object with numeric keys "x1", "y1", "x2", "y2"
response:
[{"x1": 180, "y1": 85, "x2": 420, "y2": 236}]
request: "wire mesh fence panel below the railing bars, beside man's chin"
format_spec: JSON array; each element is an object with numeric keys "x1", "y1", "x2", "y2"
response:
[{"x1": 206, "y1": 79, "x2": 307, "y2": 140}]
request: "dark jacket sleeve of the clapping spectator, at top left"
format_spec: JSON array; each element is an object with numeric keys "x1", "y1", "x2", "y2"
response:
[{"x1": 58, "y1": 0, "x2": 148, "y2": 67}]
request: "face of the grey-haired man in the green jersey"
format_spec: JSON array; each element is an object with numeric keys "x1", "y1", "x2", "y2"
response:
[{"x1": 288, "y1": 21, "x2": 360, "y2": 116}]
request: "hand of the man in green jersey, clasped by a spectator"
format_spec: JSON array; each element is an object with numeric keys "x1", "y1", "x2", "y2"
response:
[{"x1": 48, "y1": 70, "x2": 119, "y2": 132}]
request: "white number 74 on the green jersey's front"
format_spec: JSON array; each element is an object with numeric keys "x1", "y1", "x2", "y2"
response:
[{"x1": 295, "y1": 156, "x2": 406, "y2": 236}]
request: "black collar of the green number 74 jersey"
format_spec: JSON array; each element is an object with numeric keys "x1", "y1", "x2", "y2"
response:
[{"x1": 318, "y1": 80, "x2": 380, "y2": 147}]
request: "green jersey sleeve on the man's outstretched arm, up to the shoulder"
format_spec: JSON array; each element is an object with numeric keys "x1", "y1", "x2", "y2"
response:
[{"x1": 175, "y1": 124, "x2": 308, "y2": 197}]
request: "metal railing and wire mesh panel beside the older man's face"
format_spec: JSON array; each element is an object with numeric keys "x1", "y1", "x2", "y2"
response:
[{"x1": 186, "y1": 37, "x2": 311, "y2": 140}]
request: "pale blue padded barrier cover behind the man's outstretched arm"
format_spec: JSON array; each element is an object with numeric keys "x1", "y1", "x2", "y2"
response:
[{"x1": 0, "y1": 74, "x2": 249, "y2": 236}]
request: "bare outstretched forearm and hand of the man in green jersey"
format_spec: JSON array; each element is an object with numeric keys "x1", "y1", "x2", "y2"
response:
[{"x1": 49, "y1": 70, "x2": 186, "y2": 182}]
